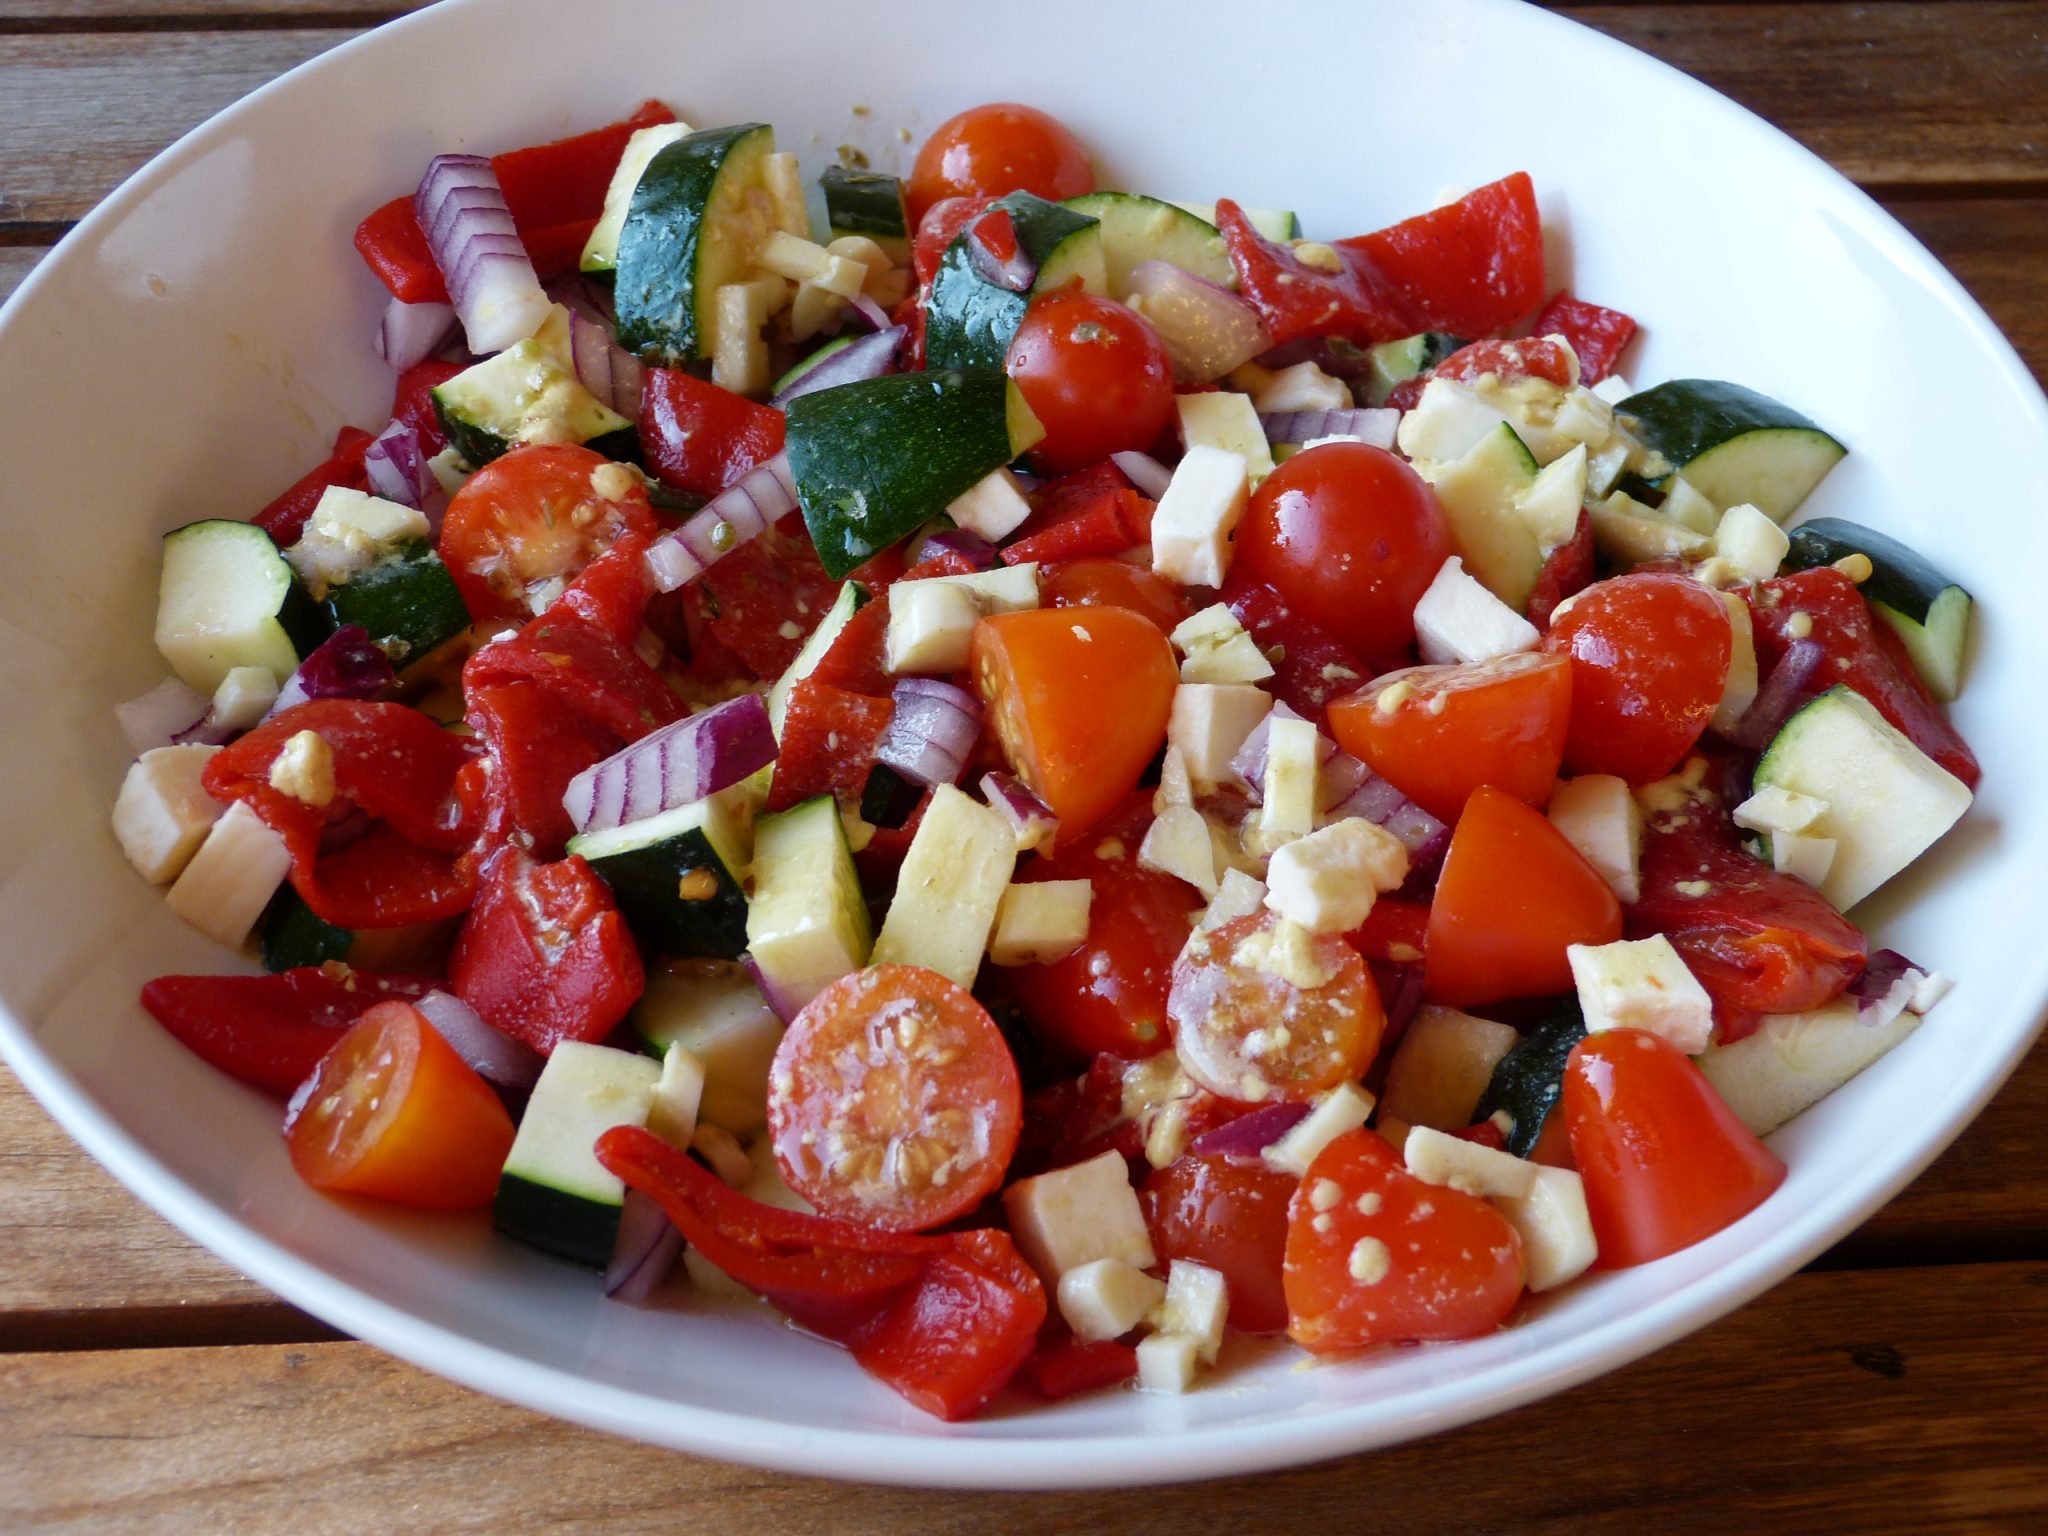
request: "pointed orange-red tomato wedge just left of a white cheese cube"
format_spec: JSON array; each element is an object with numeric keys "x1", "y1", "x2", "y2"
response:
[{"x1": 1423, "y1": 788, "x2": 1622, "y2": 1008}]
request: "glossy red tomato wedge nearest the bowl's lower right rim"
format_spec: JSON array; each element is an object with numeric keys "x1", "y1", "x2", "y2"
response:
[{"x1": 1563, "y1": 1030, "x2": 1786, "y2": 1270}]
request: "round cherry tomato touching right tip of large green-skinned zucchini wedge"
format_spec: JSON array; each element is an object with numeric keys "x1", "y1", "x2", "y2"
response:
[{"x1": 1004, "y1": 287, "x2": 1174, "y2": 475}]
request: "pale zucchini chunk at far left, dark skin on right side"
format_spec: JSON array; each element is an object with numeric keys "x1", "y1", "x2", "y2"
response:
[{"x1": 156, "y1": 518, "x2": 328, "y2": 698}]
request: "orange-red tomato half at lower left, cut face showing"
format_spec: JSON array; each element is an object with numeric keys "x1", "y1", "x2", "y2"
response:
[{"x1": 285, "y1": 1001, "x2": 512, "y2": 1210}]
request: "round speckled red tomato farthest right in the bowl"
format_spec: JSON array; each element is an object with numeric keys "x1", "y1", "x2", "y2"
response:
[{"x1": 1542, "y1": 571, "x2": 1735, "y2": 784}]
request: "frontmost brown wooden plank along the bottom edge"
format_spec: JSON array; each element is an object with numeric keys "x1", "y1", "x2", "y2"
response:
[{"x1": 0, "y1": 1264, "x2": 2048, "y2": 1536}]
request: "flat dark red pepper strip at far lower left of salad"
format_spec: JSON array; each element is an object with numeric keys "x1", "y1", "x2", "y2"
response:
[{"x1": 141, "y1": 965, "x2": 434, "y2": 1094}]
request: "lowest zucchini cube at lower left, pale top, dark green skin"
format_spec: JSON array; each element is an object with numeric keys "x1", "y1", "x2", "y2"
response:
[{"x1": 492, "y1": 1040, "x2": 662, "y2": 1266}]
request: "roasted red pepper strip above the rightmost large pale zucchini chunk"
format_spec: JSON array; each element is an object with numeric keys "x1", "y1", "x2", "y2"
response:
[{"x1": 1749, "y1": 565, "x2": 1980, "y2": 788}]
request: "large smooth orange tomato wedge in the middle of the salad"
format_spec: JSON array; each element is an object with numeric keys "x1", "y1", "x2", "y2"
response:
[{"x1": 969, "y1": 608, "x2": 1180, "y2": 840}]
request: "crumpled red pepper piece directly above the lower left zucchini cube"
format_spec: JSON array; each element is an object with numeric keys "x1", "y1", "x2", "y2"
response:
[{"x1": 449, "y1": 846, "x2": 647, "y2": 1055}]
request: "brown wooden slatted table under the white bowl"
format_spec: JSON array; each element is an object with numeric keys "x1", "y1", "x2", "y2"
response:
[{"x1": 0, "y1": 0, "x2": 2048, "y2": 1536}]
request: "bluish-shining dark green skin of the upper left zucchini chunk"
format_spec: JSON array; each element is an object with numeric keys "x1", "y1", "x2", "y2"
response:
[{"x1": 610, "y1": 123, "x2": 774, "y2": 366}]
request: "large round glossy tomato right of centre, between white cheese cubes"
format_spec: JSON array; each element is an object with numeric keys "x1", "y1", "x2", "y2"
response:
[{"x1": 1225, "y1": 442, "x2": 1450, "y2": 657}]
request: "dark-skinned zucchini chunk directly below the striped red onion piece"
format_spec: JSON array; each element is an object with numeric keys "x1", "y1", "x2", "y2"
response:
[{"x1": 569, "y1": 795, "x2": 748, "y2": 961}]
